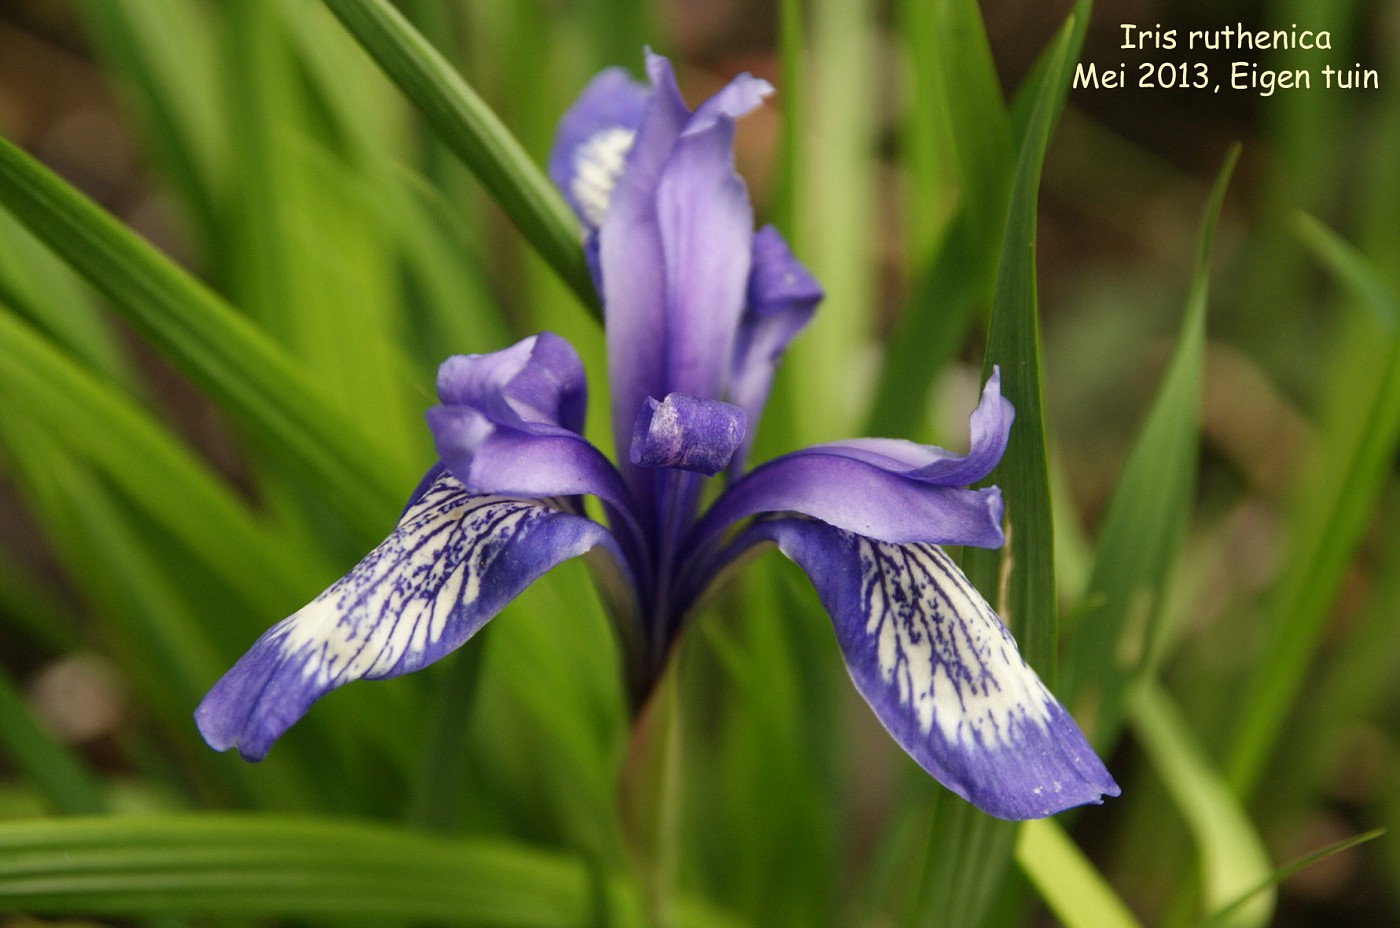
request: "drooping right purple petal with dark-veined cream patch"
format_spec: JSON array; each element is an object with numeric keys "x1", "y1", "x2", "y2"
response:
[{"x1": 750, "y1": 519, "x2": 1119, "y2": 820}]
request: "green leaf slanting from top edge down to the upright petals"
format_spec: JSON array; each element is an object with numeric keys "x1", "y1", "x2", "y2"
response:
[{"x1": 325, "y1": 0, "x2": 601, "y2": 318}]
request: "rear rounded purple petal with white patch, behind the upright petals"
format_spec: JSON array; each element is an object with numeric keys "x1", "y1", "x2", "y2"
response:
[{"x1": 549, "y1": 67, "x2": 647, "y2": 231}]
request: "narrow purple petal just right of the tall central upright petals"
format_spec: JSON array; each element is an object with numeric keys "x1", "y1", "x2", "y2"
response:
[{"x1": 729, "y1": 225, "x2": 823, "y2": 469}]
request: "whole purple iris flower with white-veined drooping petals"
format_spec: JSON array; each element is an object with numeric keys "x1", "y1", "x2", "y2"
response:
[{"x1": 196, "y1": 56, "x2": 1119, "y2": 819}]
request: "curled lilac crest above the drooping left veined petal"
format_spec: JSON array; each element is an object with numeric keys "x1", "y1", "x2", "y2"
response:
[{"x1": 437, "y1": 332, "x2": 588, "y2": 433}]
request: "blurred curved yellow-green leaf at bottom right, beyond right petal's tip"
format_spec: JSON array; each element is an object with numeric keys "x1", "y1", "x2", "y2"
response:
[{"x1": 1130, "y1": 680, "x2": 1274, "y2": 928}]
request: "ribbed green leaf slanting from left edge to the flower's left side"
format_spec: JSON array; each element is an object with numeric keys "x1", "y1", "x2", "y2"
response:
[{"x1": 0, "y1": 132, "x2": 405, "y2": 536}]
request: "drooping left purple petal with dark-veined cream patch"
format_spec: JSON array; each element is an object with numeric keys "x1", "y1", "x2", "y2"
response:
[{"x1": 195, "y1": 474, "x2": 626, "y2": 760}]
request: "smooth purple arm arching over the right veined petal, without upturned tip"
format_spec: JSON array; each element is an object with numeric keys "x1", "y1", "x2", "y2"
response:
[{"x1": 686, "y1": 447, "x2": 1005, "y2": 551}]
